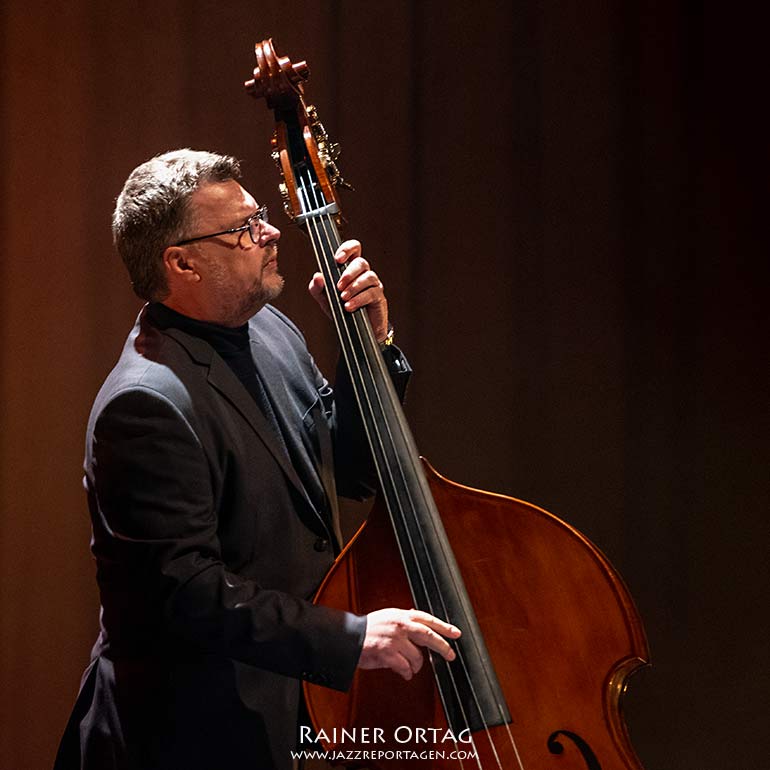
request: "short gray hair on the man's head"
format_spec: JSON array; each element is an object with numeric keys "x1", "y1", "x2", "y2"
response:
[{"x1": 112, "y1": 149, "x2": 241, "y2": 301}]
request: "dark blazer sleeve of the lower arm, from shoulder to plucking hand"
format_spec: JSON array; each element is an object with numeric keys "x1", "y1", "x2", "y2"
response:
[{"x1": 86, "y1": 387, "x2": 366, "y2": 690}]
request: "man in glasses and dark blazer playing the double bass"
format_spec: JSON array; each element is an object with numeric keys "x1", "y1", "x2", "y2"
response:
[{"x1": 56, "y1": 150, "x2": 459, "y2": 770}]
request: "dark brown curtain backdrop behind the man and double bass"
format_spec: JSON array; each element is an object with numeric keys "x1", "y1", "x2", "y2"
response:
[{"x1": 0, "y1": 0, "x2": 770, "y2": 770}]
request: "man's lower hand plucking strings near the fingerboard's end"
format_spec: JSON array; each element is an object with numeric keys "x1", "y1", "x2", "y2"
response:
[{"x1": 358, "y1": 608, "x2": 461, "y2": 681}]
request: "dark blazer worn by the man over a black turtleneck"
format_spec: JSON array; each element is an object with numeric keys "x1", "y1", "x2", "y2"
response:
[{"x1": 56, "y1": 306, "x2": 409, "y2": 770}]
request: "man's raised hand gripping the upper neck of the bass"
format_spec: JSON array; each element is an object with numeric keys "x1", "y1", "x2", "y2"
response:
[{"x1": 308, "y1": 240, "x2": 388, "y2": 342}]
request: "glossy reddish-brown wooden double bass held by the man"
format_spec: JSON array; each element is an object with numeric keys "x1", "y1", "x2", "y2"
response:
[{"x1": 245, "y1": 40, "x2": 649, "y2": 770}]
